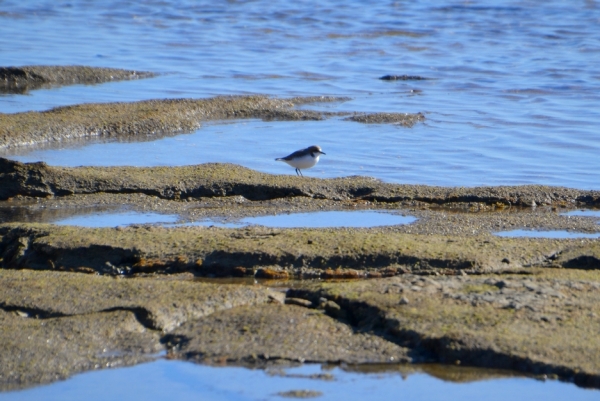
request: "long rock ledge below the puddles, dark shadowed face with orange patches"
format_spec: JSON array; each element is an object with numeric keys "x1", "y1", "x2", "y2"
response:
[{"x1": 0, "y1": 217, "x2": 600, "y2": 278}]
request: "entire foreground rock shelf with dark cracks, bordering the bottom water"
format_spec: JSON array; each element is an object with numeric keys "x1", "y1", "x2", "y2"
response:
[{"x1": 0, "y1": 269, "x2": 600, "y2": 390}]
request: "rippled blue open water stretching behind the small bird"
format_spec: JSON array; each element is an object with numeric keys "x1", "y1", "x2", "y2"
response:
[{"x1": 0, "y1": 0, "x2": 600, "y2": 189}]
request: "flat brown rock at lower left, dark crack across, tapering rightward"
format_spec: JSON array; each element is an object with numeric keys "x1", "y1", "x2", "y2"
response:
[{"x1": 0, "y1": 270, "x2": 271, "y2": 390}]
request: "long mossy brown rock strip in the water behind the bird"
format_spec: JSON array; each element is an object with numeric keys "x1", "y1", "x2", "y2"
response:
[{"x1": 0, "y1": 95, "x2": 425, "y2": 148}]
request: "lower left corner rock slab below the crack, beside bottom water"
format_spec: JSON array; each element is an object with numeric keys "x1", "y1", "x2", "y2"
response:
[{"x1": 0, "y1": 309, "x2": 162, "y2": 391}]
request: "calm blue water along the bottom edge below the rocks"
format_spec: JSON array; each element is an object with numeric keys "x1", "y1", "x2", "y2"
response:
[{"x1": 0, "y1": 360, "x2": 599, "y2": 401}]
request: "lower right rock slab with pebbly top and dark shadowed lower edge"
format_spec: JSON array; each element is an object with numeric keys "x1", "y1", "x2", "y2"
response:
[{"x1": 288, "y1": 270, "x2": 600, "y2": 387}]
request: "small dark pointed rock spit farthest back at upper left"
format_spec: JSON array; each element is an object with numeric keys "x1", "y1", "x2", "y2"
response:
[{"x1": 0, "y1": 65, "x2": 154, "y2": 93}]
